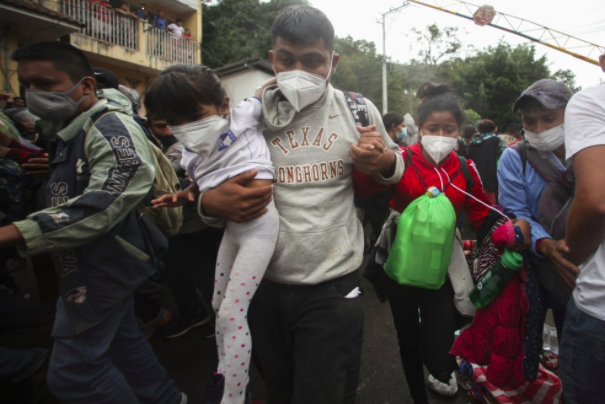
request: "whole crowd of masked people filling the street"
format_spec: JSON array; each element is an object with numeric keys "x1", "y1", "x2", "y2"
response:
[{"x1": 0, "y1": 3, "x2": 605, "y2": 404}]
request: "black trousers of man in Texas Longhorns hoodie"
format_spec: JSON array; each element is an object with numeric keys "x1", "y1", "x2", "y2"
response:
[{"x1": 248, "y1": 272, "x2": 363, "y2": 404}]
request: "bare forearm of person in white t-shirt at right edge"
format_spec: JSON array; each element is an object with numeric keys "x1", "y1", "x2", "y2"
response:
[{"x1": 565, "y1": 195, "x2": 605, "y2": 265}]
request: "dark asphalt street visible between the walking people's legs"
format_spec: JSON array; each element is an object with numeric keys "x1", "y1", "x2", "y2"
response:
[{"x1": 151, "y1": 266, "x2": 474, "y2": 404}]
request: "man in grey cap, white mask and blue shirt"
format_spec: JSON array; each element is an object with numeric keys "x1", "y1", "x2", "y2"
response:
[{"x1": 498, "y1": 79, "x2": 577, "y2": 348}]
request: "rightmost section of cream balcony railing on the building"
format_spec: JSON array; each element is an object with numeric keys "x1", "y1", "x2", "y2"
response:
[{"x1": 146, "y1": 28, "x2": 197, "y2": 63}]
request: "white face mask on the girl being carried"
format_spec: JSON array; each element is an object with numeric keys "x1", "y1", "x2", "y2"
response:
[{"x1": 168, "y1": 115, "x2": 229, "y2": 158}]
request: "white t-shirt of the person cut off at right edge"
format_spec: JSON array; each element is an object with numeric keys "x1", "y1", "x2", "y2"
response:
[{"x1": 565, "y1": 85, "x2": 605, "y2": 321}]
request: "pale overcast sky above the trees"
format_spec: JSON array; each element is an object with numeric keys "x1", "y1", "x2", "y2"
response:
[{"x1": 302, "y1": 0, "x2": 605, "y2": 88}]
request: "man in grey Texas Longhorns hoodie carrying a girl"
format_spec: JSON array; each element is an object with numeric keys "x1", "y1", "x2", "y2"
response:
[{"x1": 200, "y1": 6, "x2": 403, "y2": 404}]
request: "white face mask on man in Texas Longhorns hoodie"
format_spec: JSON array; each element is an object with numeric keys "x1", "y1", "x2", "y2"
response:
[{"x1": 276, "y1": 52, "x2": 334, "y2": 112}]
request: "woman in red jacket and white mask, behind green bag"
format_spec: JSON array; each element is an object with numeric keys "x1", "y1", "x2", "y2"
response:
[{"x1": 360, "y1": 83, "x2": 488, "y2": 404}]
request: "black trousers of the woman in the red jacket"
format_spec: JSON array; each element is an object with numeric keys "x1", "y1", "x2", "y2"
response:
[{"x1": 387, "y1": 279, "x2": 458, "y2": 404}]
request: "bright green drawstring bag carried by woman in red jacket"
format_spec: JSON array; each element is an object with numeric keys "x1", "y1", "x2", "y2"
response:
[{"x1": 384, "y1": 187, "x2": 456, "y2": 289}]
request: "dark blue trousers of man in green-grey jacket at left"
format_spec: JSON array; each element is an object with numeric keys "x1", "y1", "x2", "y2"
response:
[{"x1": 47, "y1": 298, "x2": 182, "y2": 404}]
